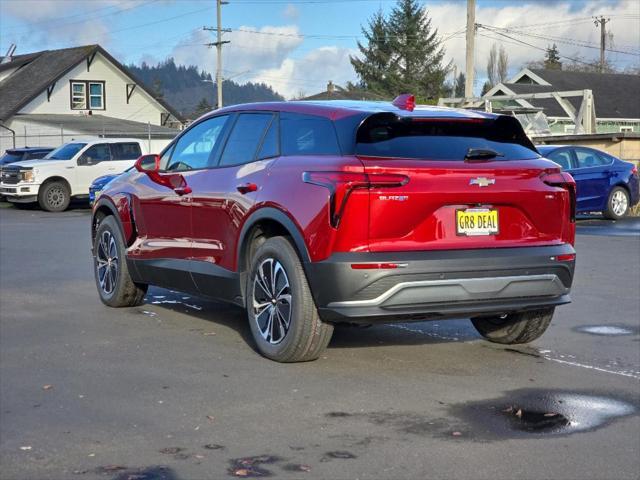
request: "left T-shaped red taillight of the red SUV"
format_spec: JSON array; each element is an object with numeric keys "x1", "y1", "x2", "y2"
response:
[{"x1": 302, "y1": 172, "x2": 409, "y2": 228}]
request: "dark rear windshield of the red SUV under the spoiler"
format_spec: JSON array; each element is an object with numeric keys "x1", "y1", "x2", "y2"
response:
[{"x1": 356, "y1": 114, "x2": 539, "y2": 161}]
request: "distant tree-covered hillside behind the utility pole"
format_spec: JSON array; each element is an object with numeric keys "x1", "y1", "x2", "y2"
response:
[{"x1": 127, "y1": 58, "x2": 284, "y2": 118}]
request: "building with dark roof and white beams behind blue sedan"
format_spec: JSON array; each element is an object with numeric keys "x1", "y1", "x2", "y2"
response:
[{"x1": 482, "y1": 68, "x2": 640, "y2": 134}]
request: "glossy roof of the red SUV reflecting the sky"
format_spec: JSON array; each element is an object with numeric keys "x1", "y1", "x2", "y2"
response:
[{"x1": 210, "y1": 100, "x2": 499, "y2": 120}]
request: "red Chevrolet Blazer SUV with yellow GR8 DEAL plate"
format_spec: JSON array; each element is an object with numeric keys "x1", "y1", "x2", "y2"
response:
[{"x1": 92, "y1": 96, "x2": 575, "y2": 362}]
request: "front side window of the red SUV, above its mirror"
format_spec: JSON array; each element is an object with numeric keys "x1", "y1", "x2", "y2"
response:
[{"x1": 166, "y1": 115, "x2": 229, "y2": 171}]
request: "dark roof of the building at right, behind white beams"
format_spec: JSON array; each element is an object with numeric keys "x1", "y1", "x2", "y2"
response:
[{"x1": 504, "y1": 69, "x2": 640, "y2": 119}]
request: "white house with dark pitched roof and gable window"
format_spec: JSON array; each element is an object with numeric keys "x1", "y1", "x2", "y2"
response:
[{"x1": 0, "y1": 45, "x2": 182, "y2": 153}]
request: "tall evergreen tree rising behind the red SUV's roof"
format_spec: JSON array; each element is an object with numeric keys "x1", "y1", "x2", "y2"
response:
[{"x1": 351, "y1": 0, "x2": 449, "y2": 101}]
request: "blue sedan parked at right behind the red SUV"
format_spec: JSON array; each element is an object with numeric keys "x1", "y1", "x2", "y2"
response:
[{"x1": 538, "y1": 145, "x2": 640, "y2": 220}]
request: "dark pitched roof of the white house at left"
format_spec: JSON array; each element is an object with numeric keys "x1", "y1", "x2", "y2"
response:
[{"x1": 0, "y1": 45, "x2": 182, "y2": 121}]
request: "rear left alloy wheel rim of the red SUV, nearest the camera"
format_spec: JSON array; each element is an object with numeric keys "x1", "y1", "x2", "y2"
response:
[{"x1": 252, "y1": 258, "x2": 291, "y2": 345}]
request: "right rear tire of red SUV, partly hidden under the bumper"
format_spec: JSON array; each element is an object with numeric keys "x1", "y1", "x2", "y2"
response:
[{"x1": 471, "y1": 307, "x2": 555, "y2": 345}]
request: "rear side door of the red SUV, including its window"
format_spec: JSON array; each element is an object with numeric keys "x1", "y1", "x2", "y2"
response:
[{"x1": 189, "y1": 112, "x2": 278, "y2": 298}]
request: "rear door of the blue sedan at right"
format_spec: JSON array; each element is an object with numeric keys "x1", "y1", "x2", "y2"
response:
[{"x1": 571, "y1": 147, "x2": 612, "y2": 212}]
